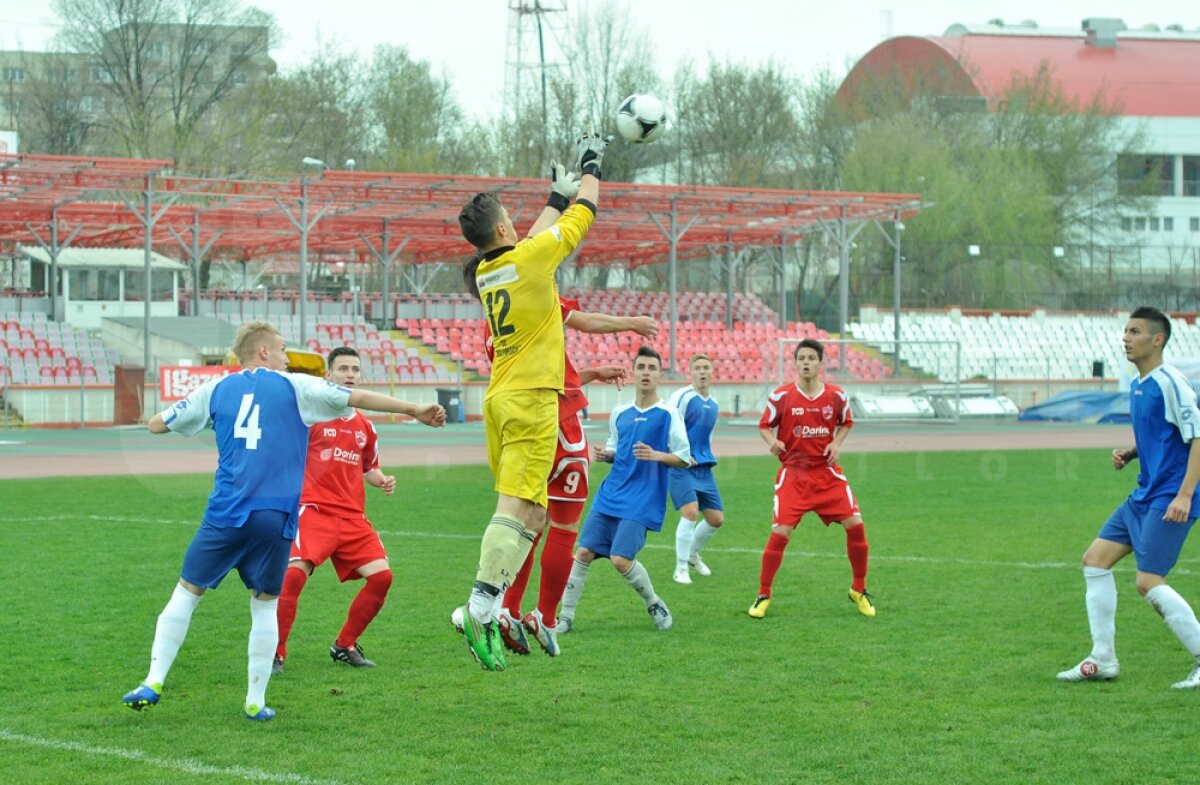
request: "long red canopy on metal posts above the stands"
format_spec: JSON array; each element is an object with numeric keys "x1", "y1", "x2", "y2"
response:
[{"x1": 0, "y1": 155, "x2": 920, "y2": 266}]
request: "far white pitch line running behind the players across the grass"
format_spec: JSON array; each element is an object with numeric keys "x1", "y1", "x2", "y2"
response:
[{"x1": 0, "y1": 515, "x2": 1200, "y2": 575}]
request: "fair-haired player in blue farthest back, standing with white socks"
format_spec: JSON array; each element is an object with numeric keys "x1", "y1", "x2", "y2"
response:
[{"x1": 667, "y1": 354, "x2": 725, "y2": 583}]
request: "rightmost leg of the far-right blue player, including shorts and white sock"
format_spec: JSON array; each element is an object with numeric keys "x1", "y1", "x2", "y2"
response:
[{"x1": 1136, "y1": 510, "x2": 1200, "y2": 689}]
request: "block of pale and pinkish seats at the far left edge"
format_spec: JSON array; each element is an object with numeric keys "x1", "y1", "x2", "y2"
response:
[{"x1": 0, "y1": 311, "x2": 120, "y2": 386}]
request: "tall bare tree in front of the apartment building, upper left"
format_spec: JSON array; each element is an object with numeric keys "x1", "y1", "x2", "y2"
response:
[{"x1": 54, "y1": 0, "x2": 275, "y2": 162}]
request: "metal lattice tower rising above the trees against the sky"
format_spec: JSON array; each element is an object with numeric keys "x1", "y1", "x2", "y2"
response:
[{"x1": 504, "y1": 0, "x2": 568, "y2": 128}]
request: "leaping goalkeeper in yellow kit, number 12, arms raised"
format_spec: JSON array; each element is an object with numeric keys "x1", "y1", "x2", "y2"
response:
[{"x1": 455, "y1": 133, "x2": 611, "y2": 671}]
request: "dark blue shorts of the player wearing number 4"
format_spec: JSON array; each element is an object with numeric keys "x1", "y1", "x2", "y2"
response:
[{"x1": 180, "y1": 510, "x2": 292, "y2": 595}]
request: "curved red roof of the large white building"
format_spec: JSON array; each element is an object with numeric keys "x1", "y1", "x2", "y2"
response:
[{"x1": 838, "y1": 19, "x2": 1200, "y2": 118}]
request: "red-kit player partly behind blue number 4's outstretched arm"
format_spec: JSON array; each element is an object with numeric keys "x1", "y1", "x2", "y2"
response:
[{"x1": 272, "y1": 346, "x2": 396, "y2": 673}]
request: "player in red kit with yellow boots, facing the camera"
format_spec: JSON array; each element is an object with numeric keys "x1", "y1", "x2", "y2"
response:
[{"x1": 750, "y1": 338, "x2": 875, "y2": 618}]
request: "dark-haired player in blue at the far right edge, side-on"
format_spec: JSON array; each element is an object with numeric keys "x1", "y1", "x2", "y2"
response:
[{"x1": 1058, "y1": 307, "x2": 1200, "y2": 689}]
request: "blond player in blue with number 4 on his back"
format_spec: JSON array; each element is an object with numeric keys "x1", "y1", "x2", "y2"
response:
[{"x1": 122, "y1": 322, "x2": 445, "y2": 720}]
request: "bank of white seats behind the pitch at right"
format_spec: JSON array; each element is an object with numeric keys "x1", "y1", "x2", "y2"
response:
[{"x1": 851, "y1": 310, "x2": 1200, "y2": 382}]
